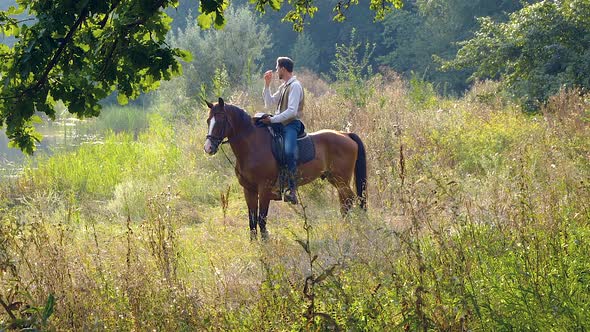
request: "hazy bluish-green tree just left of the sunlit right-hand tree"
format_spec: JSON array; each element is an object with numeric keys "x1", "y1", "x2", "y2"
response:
[{"x1": 379, "y1": 0, "x2": 522, "y2": 93}]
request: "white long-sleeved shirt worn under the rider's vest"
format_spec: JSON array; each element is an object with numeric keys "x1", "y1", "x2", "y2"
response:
[{"x1": 262, "y1": 76, "x2": 303, "y2": 123}]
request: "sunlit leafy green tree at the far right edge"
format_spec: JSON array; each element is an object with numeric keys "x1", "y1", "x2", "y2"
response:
[{"x1": 444, "y1": 0, "x2": 590, "y2": 111}]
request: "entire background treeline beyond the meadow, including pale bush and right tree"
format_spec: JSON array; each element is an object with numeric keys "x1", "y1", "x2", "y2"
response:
[{"x1": 0, "y1": 0, "x2": 590, "y2": 111}]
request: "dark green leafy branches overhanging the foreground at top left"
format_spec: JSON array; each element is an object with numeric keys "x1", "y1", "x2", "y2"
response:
[{"x1": 0, "y1": 0, "x2": 401, "y2": 153}]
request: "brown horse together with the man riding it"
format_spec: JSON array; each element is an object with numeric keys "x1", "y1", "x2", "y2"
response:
[{"x1": 203, "y1": 57, "x2": 367, "y2": 240}]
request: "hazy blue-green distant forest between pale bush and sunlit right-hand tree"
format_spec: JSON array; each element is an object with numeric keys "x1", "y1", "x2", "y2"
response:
[{"x1": 169, "y1": 0, "x2": 526, "y2": 95}]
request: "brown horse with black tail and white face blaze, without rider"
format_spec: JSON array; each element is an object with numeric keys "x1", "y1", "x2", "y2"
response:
[{"x1": 204, "y1": 98, "x2": 367, "y2": 239}]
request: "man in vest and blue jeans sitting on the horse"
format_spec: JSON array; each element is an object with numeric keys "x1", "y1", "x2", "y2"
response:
[{"x1": 261, "y1": 57, "x2": 304, "y2": 204}]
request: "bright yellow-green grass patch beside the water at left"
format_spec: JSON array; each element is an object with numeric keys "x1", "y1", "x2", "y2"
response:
[{"x1": 20, "y1": 114, "x2": 179, "y2": 198}]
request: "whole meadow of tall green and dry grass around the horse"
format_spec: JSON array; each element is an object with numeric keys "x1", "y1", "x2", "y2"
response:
[{"x1": 0, "y1": 73, "x2": 590, "y2": 331}]
